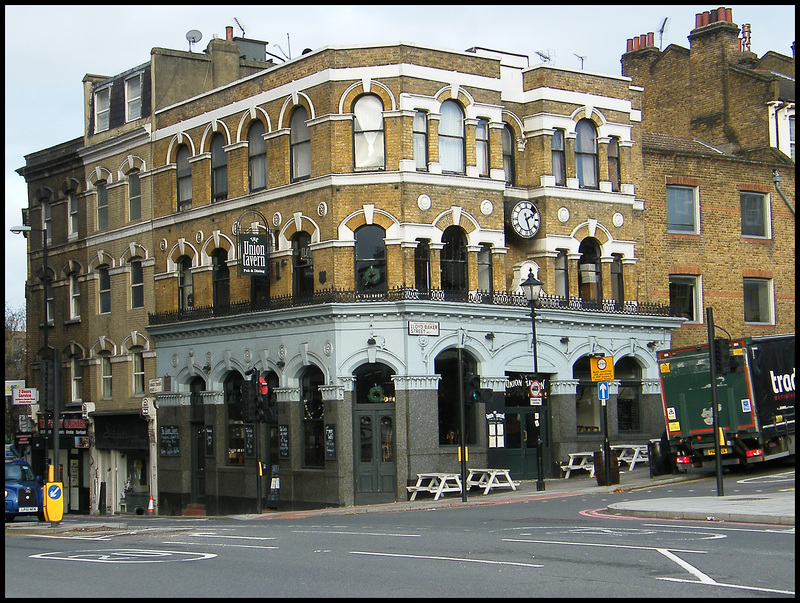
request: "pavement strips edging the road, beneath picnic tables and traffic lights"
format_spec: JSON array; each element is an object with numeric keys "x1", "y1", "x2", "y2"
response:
[{"x1": 6, "y1": 465, "x2": 795, "y2": 534}]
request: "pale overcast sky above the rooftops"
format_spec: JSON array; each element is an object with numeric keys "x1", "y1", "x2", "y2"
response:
[{"x1": 5, "y1": 3, "x2": 795, "y2": 308}]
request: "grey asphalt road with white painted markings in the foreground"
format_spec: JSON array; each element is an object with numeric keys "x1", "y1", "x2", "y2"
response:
[{"x1": 5, "y1": 468, "x2": 795, "y2": 598}]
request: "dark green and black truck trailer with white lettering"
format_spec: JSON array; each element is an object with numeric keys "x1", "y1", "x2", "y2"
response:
[{"x1": 658, "y1": 335, "x2": 795, "y2": 467}]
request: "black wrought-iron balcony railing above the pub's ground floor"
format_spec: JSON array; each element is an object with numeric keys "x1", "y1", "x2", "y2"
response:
[{"x1": 148, "y1": 287, "x2": 680, "y2": 326}]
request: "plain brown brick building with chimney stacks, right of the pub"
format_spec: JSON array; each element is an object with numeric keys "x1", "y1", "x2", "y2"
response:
[{"x1": 622, "y1": 8, "x2": 796, "y2": 347}]
